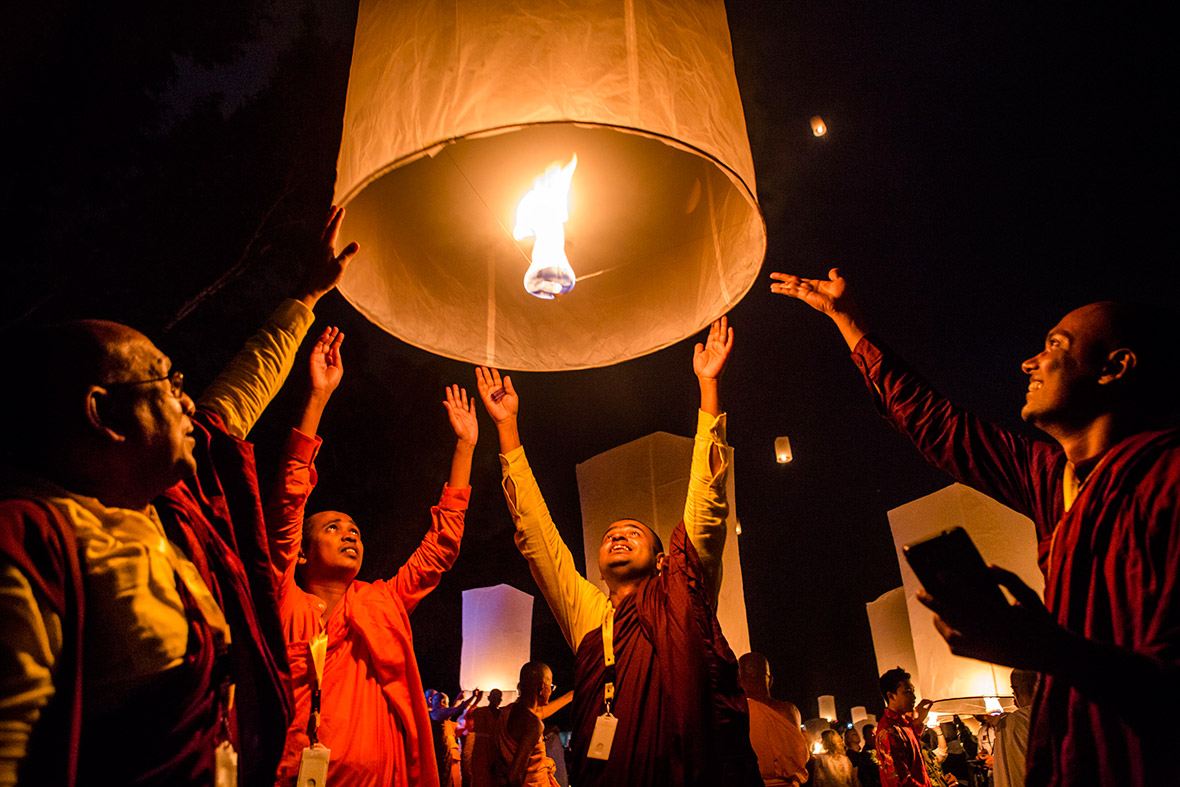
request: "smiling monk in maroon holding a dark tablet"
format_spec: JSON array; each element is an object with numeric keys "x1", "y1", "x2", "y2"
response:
[{"x1": 772, "y1": 269, "x2": 1180, "y2": 787}]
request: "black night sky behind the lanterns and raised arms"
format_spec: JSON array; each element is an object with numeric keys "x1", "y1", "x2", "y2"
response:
[{"x1": 0, "y1": 0, "x2": 1176, "y2": 717}]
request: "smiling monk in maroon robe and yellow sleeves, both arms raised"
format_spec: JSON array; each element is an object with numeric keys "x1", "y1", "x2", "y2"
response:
[{"x1": 478, "y1": 317, "x2": 762, "y2": 787}]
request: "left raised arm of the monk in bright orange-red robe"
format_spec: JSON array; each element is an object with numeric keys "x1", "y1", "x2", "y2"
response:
[{"x1": 266, "y1": 327, "x2": 345, "y2": 579}]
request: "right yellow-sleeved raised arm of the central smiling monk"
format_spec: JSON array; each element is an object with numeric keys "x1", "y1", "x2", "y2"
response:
[{"x1": 684, "y1": 317, "x2": 734, "y2": 602}]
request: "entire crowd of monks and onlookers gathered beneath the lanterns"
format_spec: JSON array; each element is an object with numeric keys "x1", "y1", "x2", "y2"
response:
[{"x1": 0, "y1": 208, "x2": 1180, "y2": 787}]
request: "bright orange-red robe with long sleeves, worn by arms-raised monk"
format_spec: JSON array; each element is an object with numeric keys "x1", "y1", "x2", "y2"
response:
[{"x1": 268, "y1": 429, "x2": 471, "y2": 787}]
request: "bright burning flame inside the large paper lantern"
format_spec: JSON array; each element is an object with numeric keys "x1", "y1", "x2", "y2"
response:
[{"x1": 512, "y1": 153, "x2": 578, "y2": 300}]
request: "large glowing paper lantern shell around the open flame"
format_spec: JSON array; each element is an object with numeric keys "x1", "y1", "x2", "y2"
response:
[{"x1": 335, "y1": 0, "x2": 766, "y2": 370}]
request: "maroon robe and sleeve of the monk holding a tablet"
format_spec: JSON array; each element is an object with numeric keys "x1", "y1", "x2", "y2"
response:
[{"x1": 853, "y1": 336, "x2": 1180, "y2": 787}]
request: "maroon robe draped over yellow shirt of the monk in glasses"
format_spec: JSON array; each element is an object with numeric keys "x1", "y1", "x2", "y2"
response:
[{"x1": 0, "y1": 411, "x2": 290, "y2": 787}]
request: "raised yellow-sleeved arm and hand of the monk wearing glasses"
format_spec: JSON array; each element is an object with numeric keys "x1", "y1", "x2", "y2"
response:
[{"x1": 197, "y1": 206, "x2": 359, "y2": 438}]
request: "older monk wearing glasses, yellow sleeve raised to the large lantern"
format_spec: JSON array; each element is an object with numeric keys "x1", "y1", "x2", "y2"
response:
[{"x1": 0, "y1": 209, "x2": 356, "y2": 787}]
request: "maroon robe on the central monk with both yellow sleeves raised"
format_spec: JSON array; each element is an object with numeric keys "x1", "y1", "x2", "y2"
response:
[{"x1": 571, "y1": 523, "x2": 762, "y2": 787}]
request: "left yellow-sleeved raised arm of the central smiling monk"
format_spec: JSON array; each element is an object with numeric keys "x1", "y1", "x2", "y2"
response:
[{"x1": 476, "y1": 367, "x2": 610, "y2": 650}]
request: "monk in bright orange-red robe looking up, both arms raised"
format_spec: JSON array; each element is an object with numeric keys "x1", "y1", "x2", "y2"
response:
[{"x1": 267, "y1": 328, "x2": 478, "y2": 787}]
